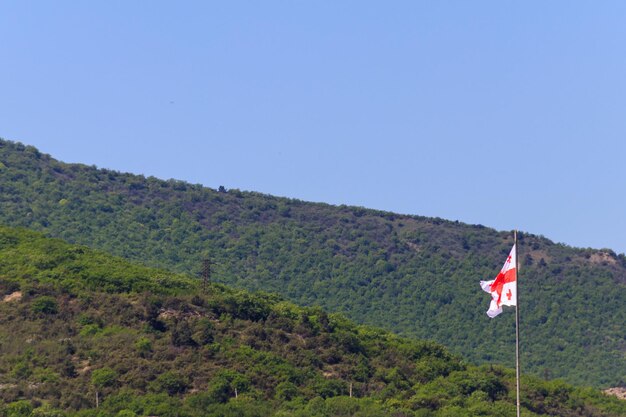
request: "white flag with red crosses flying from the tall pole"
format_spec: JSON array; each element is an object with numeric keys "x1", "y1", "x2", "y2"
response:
[{"x1": 480, "y1": 245, "x2": 517, "y2": 318}]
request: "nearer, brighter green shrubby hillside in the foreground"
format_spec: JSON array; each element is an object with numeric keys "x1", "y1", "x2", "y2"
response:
[{"x1": 0, "y1": 227, "x2": 626, "y2": 417}]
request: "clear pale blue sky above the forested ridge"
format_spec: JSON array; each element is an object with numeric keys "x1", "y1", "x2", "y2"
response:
[{"x1": 0, "y1": 0, "x2": 626, "y2": 253}]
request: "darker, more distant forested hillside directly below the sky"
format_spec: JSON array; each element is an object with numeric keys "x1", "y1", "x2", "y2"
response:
[{"x1": 0, "y1": 141, "x2": 626, "y2": 387}]
